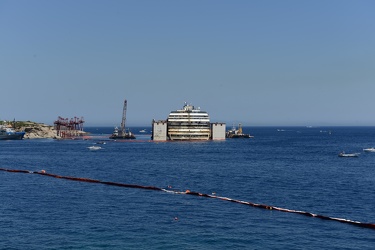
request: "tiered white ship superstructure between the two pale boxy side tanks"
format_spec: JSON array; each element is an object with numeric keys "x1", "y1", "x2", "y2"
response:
[{"x1": 167, "y1": 102, "x2": 211, "y2": 140}]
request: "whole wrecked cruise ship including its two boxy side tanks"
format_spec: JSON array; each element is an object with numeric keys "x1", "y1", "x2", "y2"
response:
[{"x1": 152, "y1": 102, "x2": 225, "y2": 141}]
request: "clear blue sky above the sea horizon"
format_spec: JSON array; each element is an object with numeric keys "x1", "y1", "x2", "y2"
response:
[{"x1": 0, "y1": 0, "x2": 375, "y2": 126}]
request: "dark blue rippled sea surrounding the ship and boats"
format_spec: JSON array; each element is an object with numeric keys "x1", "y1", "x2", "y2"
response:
[{"x1": 0, "y1": 127, "x2": 375, "y2": 249}]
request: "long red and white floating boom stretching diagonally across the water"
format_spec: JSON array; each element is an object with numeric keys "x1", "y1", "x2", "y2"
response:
[{"x1": 0, "y1": 168, "x2": 375, "y2": 229}]
